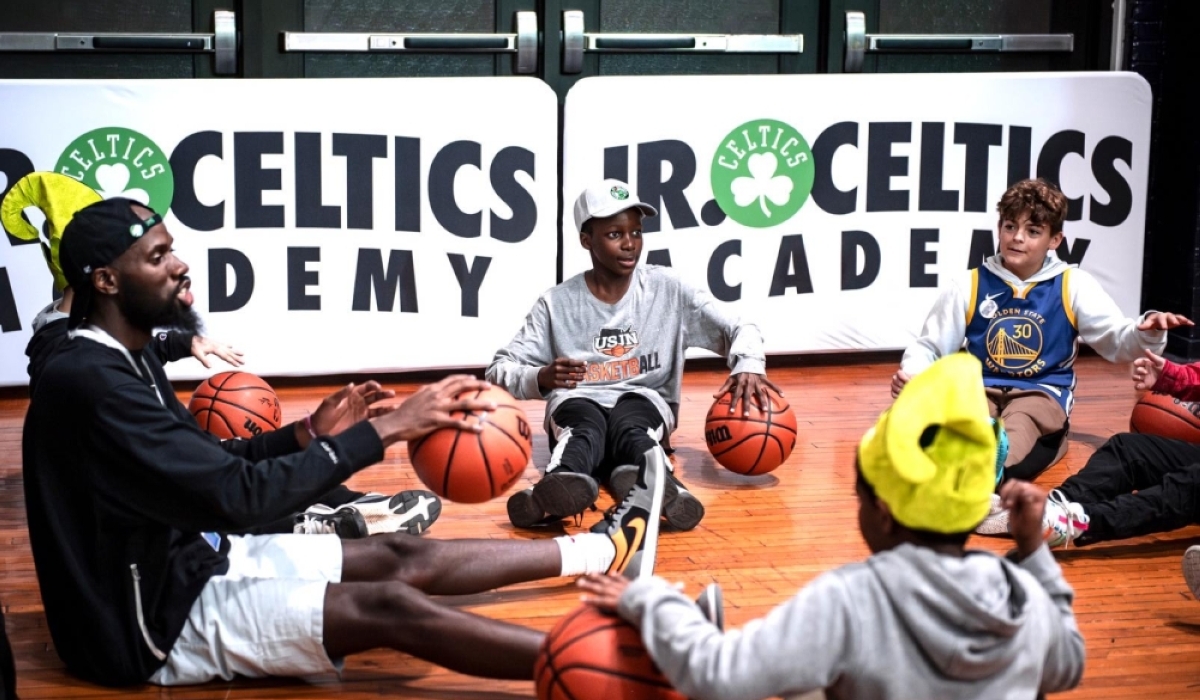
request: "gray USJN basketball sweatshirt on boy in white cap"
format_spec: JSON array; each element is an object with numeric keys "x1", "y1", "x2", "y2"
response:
[{"x1": 486, "y1": 265, "x2": 766, "y2": 431}]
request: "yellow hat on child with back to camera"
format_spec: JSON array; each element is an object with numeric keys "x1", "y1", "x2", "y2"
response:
[{"x1": 858, "y1": 353, "x2": 997, "y2": 534}]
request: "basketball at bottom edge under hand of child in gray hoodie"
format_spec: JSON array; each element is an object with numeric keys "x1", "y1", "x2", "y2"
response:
[{"x1": 533, "y1": 605, "x2": 684, "y2": 700}]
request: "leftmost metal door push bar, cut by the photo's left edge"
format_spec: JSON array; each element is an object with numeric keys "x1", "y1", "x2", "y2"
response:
[{"x1": 0, "y1": 10, "x2": 238, "y2": 76}]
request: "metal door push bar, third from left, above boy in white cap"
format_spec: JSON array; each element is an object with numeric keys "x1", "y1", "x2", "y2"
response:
[{"x1": 563, "y1": 10, "x2": 804, "y2": 73}]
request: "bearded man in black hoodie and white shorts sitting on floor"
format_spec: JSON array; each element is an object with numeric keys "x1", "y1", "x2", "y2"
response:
[{"x1": 23, "y1": 199, "x2": 658, "y2": 686}]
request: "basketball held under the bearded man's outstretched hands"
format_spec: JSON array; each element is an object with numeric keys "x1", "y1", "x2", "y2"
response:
[{"x1": 408, "y1": 387, "x2": 533, "y2": 503}]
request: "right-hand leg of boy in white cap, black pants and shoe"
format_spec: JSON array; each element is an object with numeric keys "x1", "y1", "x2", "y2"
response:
[{"x1": 607, "y1": 394, "x2": 704, "y2": 530}]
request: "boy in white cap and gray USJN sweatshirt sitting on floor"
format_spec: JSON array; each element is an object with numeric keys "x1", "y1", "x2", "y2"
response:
[{"x1": 487, "y1": 180, "x2": 779, "y2": 530}]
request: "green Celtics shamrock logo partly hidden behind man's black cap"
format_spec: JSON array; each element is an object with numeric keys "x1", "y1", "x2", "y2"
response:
[{"x1": 54, "y1": 126, "x2": 175, "y2": 214}]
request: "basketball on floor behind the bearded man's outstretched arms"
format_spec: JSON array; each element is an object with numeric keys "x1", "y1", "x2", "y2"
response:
[{"x1": 187, "y1": 372, "x2": 280, "y2": 439}]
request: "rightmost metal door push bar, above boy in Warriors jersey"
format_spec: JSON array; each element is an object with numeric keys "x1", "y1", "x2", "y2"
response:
[{"x1": 842, "y1": 12, "x2": 1075, "y2": 73}]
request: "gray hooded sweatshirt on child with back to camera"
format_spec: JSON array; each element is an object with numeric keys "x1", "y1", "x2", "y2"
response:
[{"x1": 619, "y1": 545, "x2": 1084, "y2": 700}]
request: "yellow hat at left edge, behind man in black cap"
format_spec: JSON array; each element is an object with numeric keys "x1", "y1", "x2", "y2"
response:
[{"x1": 0, "y1": 173, "x2": 101, "y2": 291}]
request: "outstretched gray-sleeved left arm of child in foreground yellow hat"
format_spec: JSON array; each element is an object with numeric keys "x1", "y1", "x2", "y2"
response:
[{"x1": 580, "y1": 574, "x2": 856, "y2": 700}]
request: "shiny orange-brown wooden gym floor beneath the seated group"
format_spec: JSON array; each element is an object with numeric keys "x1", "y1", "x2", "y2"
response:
[{"x1": 0, "y1": 354, "x2": 1200, "y2": 700}]
